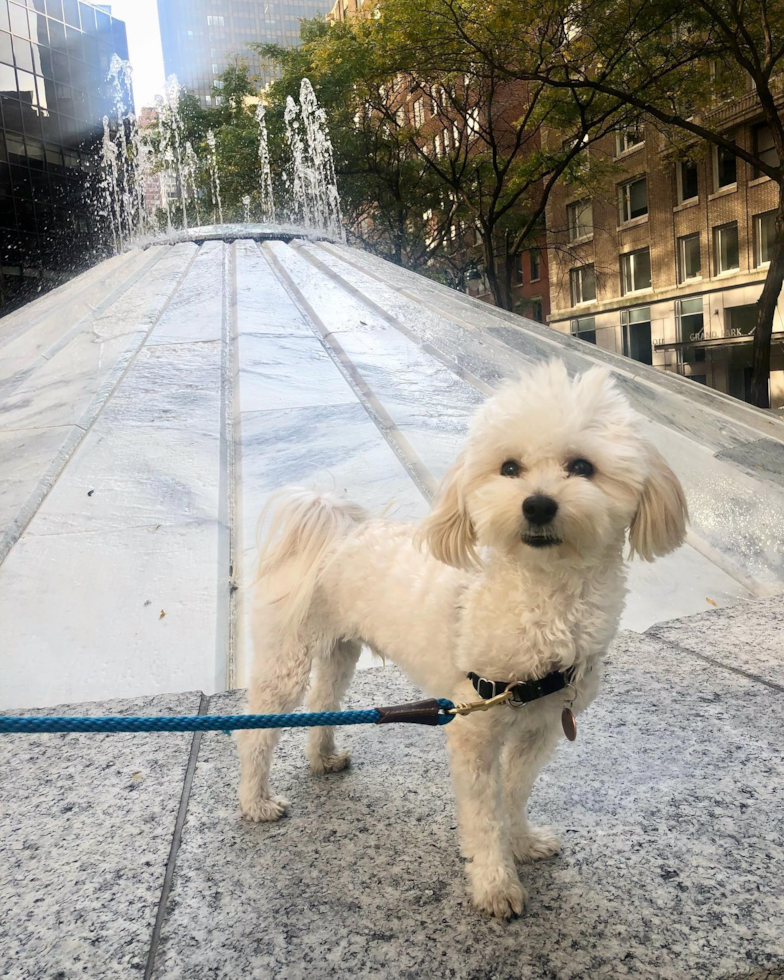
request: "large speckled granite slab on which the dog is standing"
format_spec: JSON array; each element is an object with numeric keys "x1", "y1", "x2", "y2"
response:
[{"x1": 153, "y1": 633, "x2": 784, "y2": 980}]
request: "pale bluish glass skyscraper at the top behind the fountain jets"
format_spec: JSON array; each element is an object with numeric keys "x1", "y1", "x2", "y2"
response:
[{"x1": 158, "y1": 0, "x2": 334, "y2": 105}]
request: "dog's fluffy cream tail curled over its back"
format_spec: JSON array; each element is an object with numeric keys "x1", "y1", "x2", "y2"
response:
[{"x1": 256, "y1": 487, "x2": 368, "y2": 631}]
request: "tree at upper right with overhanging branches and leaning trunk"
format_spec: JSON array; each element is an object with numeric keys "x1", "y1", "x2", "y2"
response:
[{"x1": 398, "y1": 0, "x2": 784, "y2": 408}]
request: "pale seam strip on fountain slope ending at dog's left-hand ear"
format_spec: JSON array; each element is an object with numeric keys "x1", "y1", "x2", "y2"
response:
[{"x1": 261, "y1": 245, "x2": 438, "y2": 503}]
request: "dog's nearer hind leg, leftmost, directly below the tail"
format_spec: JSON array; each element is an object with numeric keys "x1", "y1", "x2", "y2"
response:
[{"x1": 237, "y1": 629, "x2": 313, "y2": 821}]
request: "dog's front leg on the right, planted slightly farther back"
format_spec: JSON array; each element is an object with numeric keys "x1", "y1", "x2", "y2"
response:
[{"x1": 501, "y1": 728, "x2": 561, "y2": 861}]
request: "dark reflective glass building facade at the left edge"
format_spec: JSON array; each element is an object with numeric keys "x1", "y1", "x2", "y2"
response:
[{"x1": 0, "y1": 0, "x2": 128, "y2": 310}]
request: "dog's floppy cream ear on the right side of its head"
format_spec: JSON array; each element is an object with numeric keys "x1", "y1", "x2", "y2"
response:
[{"x1": 629, "y1": 446, "x2": 689, "y2": 561}]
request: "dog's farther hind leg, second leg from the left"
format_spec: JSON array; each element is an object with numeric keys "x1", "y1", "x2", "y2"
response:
[{"x1": 305, "y1": 640, "x2": 362, "y2": 773}]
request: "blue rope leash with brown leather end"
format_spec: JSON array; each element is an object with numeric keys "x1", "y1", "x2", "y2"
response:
[{"x1": 0, "y1": 698, "x2": 455, "y2": 735}]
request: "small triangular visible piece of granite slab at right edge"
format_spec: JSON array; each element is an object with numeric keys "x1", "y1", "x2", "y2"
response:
[{"x1": 647, "y1": 595, "x2": 784, "y2": 690}]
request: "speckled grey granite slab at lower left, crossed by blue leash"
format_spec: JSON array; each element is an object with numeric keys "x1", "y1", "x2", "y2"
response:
[{"x1": 0, "y1": 692, "x2": 201, "y2": 980}]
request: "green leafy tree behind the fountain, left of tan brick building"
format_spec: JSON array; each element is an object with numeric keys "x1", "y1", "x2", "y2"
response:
[{"x1": 259, "y1": 0, "x2": 628, "y2": 309}]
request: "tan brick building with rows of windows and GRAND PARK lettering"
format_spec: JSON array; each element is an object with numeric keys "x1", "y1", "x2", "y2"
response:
[{"x1": 548, "y1": 94, "x2": 784, "y2": 408}]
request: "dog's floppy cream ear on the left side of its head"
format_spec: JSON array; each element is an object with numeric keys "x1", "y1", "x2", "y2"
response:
[{"x1": 416, "y1": 453, "x2": 479, "y2": 568}]
